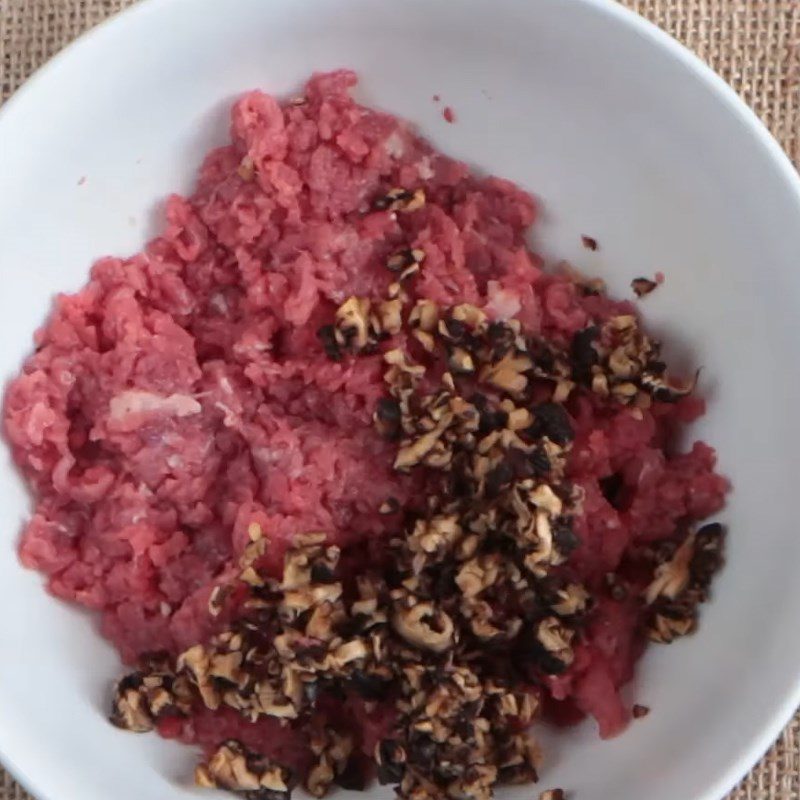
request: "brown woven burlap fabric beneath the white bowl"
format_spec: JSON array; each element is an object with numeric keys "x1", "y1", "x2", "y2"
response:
[{"x1": 0, "y1": 0, "x2": 800, "y2": 800}]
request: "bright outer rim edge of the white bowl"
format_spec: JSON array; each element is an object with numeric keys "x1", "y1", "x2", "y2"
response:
[{"x1": 0, "y1": 0, "x2": 800, "y2": 800}]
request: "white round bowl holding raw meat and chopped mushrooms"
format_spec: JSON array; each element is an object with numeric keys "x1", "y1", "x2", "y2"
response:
[{"x1": 0, "y1": 0, "x2": 800, "y2": 800}]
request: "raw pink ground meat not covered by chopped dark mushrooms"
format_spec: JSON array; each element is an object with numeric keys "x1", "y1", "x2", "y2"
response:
[{"x1": 5, "y1": 71, "x2": 727, "y2": 762}]
